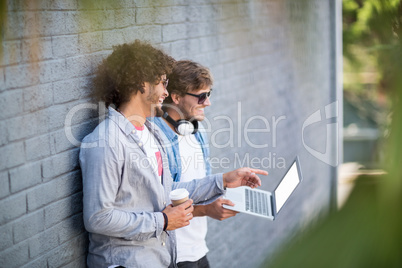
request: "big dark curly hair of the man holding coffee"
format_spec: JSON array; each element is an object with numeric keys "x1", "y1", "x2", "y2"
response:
[{"x1": 93, "y1": 40, "x2": 174, "y2": 107}]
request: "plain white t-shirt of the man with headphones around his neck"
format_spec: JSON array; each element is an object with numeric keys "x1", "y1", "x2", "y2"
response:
[{"x1": 176, "y1": 134, "x2": 208, "y2": 262}]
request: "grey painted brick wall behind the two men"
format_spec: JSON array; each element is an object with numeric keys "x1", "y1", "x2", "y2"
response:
[{"x1": 0, "y1": 0, "x2": 337, "y2": 267}]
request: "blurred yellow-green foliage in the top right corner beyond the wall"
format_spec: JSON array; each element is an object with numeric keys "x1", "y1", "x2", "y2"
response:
[{"x1": 343, "y1": 0, "x2": 402, "y2": 94}]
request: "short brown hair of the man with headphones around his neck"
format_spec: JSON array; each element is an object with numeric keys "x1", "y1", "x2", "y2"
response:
[{"x1": 164, "y1": 60, "x2": 214, "y2": 103}]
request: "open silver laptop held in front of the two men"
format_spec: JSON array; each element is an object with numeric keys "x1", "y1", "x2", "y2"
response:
[{"x1": 223, "y1": 157, "x2": 302, "y2": 220}]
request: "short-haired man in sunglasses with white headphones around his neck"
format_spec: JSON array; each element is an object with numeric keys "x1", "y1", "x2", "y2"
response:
[{"x1": 154, "y1": 60, "x2": 242, "y2": 268}]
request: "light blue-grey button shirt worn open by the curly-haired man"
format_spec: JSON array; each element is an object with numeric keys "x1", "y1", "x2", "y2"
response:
[{"x1": 80, "y1": 108, "x2": 224, "y2": 267}]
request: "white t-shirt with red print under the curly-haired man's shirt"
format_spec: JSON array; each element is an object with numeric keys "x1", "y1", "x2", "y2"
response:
[{"x1": 135, "y1": 125, "x2": 163, "y2": 181}]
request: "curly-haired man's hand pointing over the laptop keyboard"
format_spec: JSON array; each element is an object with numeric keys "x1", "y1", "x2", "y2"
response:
[{"x1": 223, "y1": 168, "x2": 268, "y2": 188}]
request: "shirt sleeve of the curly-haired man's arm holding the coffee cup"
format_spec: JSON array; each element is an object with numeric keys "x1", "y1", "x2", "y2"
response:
[{"x1": 80, "y1": 138, "x2": 164, "y2": 241}]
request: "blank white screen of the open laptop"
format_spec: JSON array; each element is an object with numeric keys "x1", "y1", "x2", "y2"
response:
[{"x1": 275, "y1": 161, "x2": 301, "y2": 213}]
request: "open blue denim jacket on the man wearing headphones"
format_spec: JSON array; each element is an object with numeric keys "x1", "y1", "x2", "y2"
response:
[{"x1": 152, "y1": 117, "x2": 211, "y2": 182}]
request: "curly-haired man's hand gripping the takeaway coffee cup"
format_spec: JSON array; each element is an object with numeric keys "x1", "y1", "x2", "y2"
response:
[{"x1": 162, "y1": 199, "x2": 194, "y2": 231}]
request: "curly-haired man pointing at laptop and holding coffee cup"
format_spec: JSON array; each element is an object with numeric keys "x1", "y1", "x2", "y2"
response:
[{"x1": 80, "y1": 41, "x2": 266, "y2": 267}]
